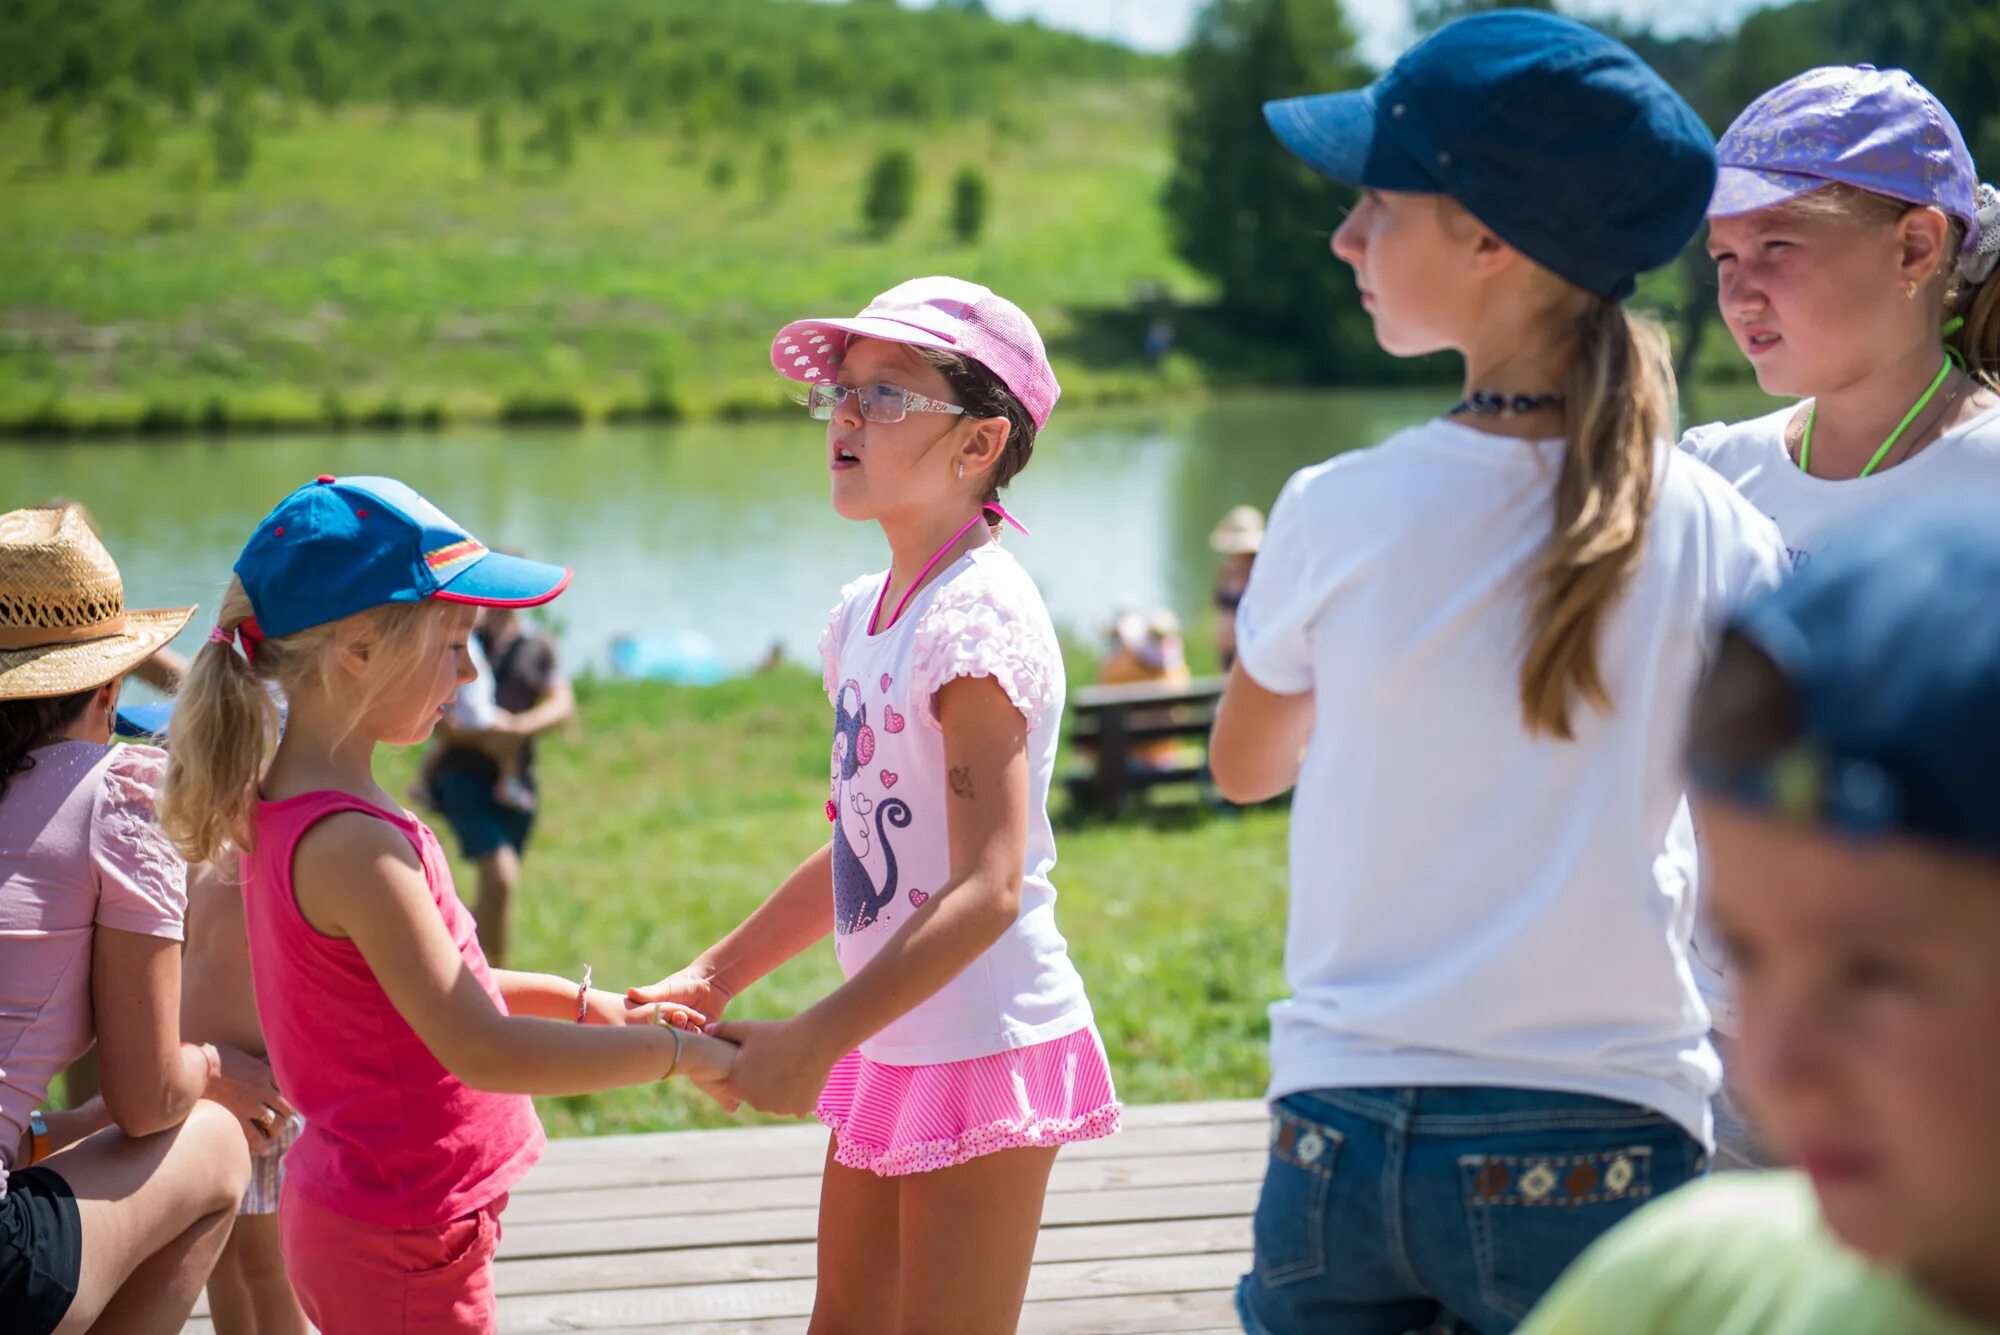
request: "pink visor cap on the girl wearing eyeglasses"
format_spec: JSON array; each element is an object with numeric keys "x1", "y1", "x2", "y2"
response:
[{"x1": 770, "y1": 278, "x2": 1062, "y2": 430}]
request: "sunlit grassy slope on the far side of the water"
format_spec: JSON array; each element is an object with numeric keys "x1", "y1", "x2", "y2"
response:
[{"x1": 0, "y1": 78, "x2": 1206, "y2": 426}]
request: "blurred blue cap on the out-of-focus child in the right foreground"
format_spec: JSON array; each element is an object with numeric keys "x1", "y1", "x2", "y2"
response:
[{"x1": 1692, "y1": 504, "x2": 2000, "y2": 857}]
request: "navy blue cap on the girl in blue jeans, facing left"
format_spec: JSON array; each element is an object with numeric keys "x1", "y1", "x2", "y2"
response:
[{"x1": 1264, "y1": 10, "x2": 1716, "y2": 298}]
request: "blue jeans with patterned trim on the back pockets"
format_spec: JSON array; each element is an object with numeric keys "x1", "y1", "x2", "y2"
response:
[{"x1": 1236, "y1": 1087, "x2": 1708, "y2": 1335}]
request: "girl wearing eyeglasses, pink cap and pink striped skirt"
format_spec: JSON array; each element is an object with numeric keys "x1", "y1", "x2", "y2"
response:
[{"x1": 632, "y1": 278, "x2": 1118, "y2": 1331}]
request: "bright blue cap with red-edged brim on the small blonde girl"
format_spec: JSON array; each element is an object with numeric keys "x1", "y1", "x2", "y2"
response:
[{"x1": 236, "y1": 474, "x2": 570, "y2": 640}]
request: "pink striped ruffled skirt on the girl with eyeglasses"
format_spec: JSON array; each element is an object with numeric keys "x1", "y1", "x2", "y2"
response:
[{"x1": 818, "y1": 1027, "x2": 1118, "y2": 1177}]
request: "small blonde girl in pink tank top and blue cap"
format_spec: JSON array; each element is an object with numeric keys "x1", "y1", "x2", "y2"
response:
[{"x1": 162, "y1": 478, "x2": 736, "y2": 1335}]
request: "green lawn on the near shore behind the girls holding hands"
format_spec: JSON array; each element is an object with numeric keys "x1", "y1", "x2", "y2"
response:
[{"x1": 368, "y1": 668, "x2": 1284, "y2": 1135}]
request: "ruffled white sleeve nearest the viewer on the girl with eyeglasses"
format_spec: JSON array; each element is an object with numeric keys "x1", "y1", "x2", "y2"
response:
[{"x1": 910, "y1": 576, "x2": 1062, "y2": 731}]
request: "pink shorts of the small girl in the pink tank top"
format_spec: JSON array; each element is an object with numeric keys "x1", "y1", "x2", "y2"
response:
[{"x1": 278, "y1": 1183, "x2": 506, "y2": 1335}]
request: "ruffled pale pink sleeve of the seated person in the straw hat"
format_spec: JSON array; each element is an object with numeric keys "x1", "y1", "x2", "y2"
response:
[{"x1": 90, "y1": 745, "x2": 188, "y2": 941}]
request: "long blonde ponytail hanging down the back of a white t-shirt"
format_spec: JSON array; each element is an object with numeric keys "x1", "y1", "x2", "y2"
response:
[{"x1": 1520, "y1": 298, "x2": 1674, "y2": 741}]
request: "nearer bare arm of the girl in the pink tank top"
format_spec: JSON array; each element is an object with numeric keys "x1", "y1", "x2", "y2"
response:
[{"x1": 292, "y1": 811, "x2": 732, "y2": 1095}]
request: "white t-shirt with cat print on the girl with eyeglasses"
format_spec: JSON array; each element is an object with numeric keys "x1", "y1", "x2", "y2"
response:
[{"x1": 820, "y1": 546, "x2": 1090, "y2": 1065}]
